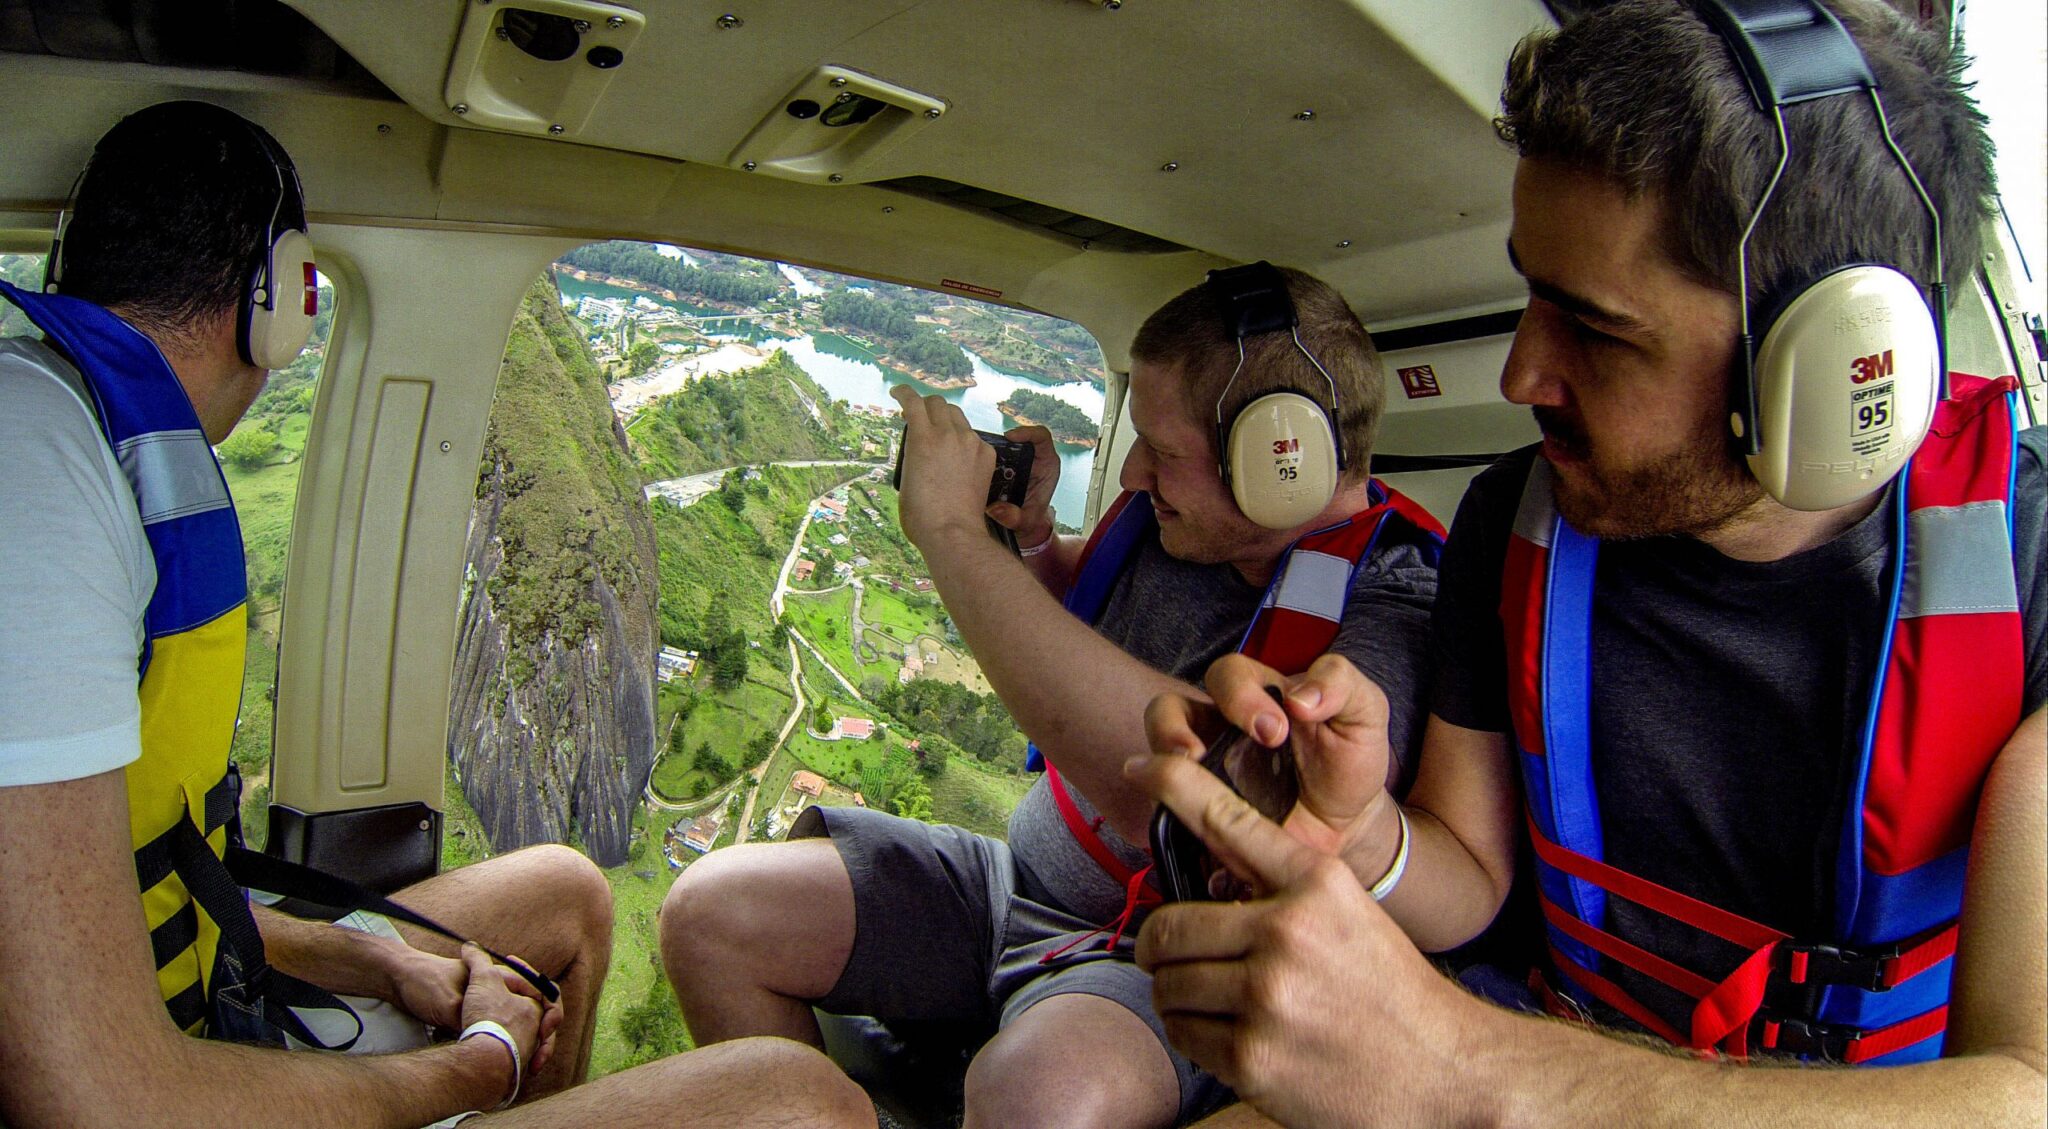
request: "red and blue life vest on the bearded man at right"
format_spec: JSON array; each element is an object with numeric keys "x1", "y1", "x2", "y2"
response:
[{"x1": 1501, "y1": 375, "x2": 2025, "y2": 1065}]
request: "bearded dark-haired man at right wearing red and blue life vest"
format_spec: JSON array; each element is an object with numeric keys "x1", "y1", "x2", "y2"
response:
[{"x1": 1133, "y1": 0, "x2": 2048, "y2": 1125}]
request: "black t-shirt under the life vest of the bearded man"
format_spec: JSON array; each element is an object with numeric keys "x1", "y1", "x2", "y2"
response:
[{"x1": 1432, "y1": 428, "x2": 2048, "y2": 1031}]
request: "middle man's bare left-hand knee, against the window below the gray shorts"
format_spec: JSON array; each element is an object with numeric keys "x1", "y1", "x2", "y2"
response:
[{"x1": 659, "y1": 838, "x2": 854, "y2": 1047}]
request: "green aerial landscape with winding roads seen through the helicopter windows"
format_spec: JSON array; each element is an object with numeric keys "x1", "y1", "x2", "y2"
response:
[{"x1": 159, "y1": 244, "x2": 1102, "y2": 1074}]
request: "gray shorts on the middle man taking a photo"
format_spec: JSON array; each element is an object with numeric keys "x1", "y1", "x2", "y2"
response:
[{"x1": 788, "y1": 807, "x2": 1231, "y2": 1123}]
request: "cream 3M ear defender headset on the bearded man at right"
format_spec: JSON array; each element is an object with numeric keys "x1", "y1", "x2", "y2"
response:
[{"x1": 1700, "y1": 0, "x2": 1948, "y2": 510}]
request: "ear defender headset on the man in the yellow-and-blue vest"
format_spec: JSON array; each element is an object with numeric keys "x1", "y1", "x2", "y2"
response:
[{"x1": 43, "y1": 102, "x2": 319, "y2": 369}]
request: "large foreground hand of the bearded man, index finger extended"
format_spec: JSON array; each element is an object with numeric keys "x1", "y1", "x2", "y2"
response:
[{"x1": 1126, "y1": 725, "x2": 1493, "y2": 1125}]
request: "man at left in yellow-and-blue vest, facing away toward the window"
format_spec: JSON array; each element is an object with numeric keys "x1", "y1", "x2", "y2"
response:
[{"x1": 0, "y1": 102, "x2": 872, "y2": 1127}]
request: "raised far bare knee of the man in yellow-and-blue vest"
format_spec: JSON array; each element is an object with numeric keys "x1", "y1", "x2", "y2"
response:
[{"x1": 391, "y1": 844, "x2": 612, "y2": 1098}]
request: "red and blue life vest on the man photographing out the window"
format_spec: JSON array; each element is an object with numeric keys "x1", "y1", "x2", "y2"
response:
[{"x1": 1026, "y1": 479, "x2": 1444, "y2": 905}]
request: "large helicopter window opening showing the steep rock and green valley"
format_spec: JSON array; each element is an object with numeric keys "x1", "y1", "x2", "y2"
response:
[{"x1": 456, "y1": 242, "x2": 1106, "y2": 1074}]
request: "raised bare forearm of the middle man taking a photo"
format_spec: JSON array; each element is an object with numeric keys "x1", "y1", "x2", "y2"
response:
[{"x1": 922, "y1": 529, "x2": 1190, "y2": 840}]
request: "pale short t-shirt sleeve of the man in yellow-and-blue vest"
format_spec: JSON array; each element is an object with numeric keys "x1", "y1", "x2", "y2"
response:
[{"x1": 0, "y1": 338, "x2": 156, "y2": 787}]
